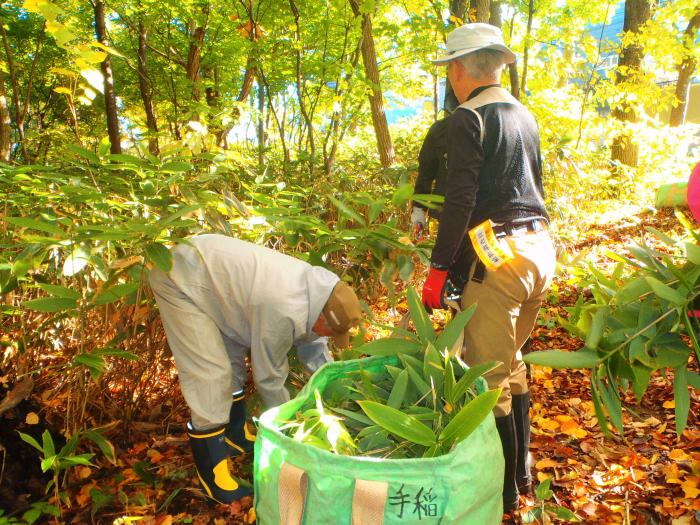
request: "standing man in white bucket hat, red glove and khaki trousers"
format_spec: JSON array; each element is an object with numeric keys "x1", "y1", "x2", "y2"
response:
[{"x1": 423, "y1": 23, "x2": 555, "y2": 512}]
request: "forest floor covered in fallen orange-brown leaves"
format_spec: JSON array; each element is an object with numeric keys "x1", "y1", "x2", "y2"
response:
[{"x1": 0, "y1": 212, "x2": 700, "y2": 525}]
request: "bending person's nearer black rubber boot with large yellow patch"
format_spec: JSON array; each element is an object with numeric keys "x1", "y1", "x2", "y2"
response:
[{"x1": 187, "y1": 423, "x2": 253, "y2": 504}]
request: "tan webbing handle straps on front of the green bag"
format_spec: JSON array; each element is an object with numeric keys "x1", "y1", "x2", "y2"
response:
[{"x1": 277, "y1": 463, "x2": 389, "y2": 525}]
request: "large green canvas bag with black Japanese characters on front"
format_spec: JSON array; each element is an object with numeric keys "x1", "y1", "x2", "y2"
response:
[{"x1": 254, "y1": 356, "x2": 504, "y2": 525}]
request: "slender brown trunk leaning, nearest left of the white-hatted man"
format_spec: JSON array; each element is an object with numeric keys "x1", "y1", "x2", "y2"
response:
[{"x1": 350, "y1": 0, "x2": 394, "y2": 168}]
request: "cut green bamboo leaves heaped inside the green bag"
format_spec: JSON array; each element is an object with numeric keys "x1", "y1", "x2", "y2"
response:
[{"x1": 283, "y1": 287, "x2": 500, "y2": 457}]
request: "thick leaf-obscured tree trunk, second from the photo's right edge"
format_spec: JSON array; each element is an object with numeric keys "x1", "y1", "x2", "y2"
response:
[{"x1": 611, "y1": 0, "x2": 651, "y2": 166}]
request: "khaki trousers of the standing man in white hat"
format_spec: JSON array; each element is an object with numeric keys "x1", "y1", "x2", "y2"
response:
[{"x1": 462, "y1": 231, "x2": 556, "y2": 417}]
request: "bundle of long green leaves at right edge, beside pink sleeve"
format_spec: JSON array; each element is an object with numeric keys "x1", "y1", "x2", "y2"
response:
[{"x1": 524, "y1": 215, "x2": 700, "y2": 436}]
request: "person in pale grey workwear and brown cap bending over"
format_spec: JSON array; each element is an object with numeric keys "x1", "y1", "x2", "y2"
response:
[{"x1": 150, "y1": 235, "x2": 361, "y2": 503}]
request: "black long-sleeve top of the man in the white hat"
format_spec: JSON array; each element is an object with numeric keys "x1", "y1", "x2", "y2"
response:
[{"x1": 431, "y1": 85, "x2": 548, "y2": 268}]
